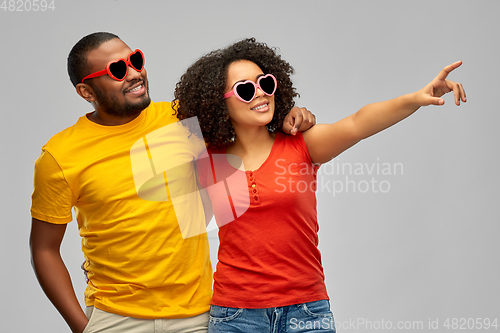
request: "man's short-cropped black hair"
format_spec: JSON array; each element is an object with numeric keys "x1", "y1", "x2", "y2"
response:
[{"x1": 68, "y1": 32, "x2": 120, "y2": 87}]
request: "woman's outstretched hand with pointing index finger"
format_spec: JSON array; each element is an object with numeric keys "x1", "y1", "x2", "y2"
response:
[{"x1": 415, "y1": 61, "x2": 467, "y2": 106}]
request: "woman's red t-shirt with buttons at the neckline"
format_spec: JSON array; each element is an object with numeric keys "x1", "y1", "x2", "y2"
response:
[{"x1": 199, "y1": 132, "x2": 328, "y2": 308}]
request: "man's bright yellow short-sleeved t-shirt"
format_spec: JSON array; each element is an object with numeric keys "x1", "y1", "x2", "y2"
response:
[{"x1": 31, "y1": 102, "x2": 212, "y2": 319}]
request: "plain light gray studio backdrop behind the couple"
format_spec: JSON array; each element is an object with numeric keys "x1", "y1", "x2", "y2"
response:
[{"x1": 0, "y1": 0, "x2": 500, "y2": 333}]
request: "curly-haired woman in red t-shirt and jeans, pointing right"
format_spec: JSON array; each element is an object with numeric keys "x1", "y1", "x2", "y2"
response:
[{"x1": 175, "y1": 38, "x2": 466, "y2": 333}]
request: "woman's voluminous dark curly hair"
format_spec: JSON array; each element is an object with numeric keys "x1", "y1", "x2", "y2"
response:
[{"x1": 173, "y1": 38, "x2": 298, "y2": 148}]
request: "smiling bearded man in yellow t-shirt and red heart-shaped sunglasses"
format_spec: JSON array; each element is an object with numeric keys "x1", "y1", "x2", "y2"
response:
[{"x1": 30, "y1": 32, "x2": 314, "y2": 333}]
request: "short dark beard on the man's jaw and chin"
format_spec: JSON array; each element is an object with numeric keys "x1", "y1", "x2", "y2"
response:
[{"x1": 92, "y1": 82, "x2": 151, "y2": 117}]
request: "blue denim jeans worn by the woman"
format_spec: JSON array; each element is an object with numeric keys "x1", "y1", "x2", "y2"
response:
[{"x1": 208, "y1": 300, "x2": 335, "y2": 333}]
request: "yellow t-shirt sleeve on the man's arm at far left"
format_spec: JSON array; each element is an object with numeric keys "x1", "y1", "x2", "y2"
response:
[{"x1": 31, "y1": 150, "x2": 76, "y2": 224}]
